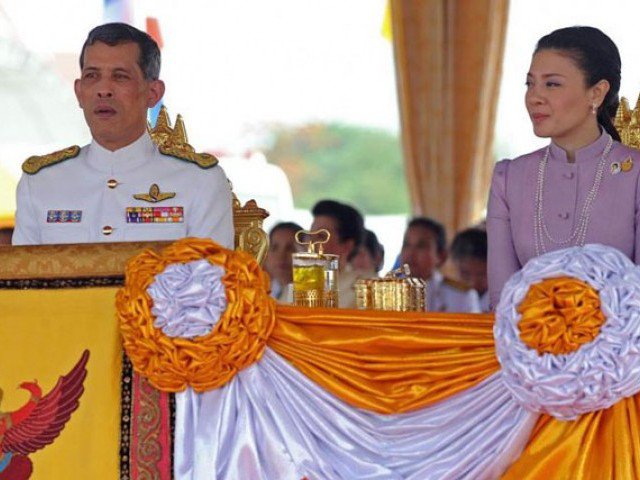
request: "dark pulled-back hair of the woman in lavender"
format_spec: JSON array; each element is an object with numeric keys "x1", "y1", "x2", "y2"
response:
[{"x1": 534, "y1": 26, "x2": 622, "y2": 141}]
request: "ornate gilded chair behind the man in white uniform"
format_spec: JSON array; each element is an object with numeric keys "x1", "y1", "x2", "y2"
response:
[{"x1": 149, "y1": 105, "x2": 269, "y2": 264}]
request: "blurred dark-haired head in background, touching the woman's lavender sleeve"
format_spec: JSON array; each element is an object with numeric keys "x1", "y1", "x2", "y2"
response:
[{"x1": 450, "y1": 228, "x2": 490, "y2": 312}]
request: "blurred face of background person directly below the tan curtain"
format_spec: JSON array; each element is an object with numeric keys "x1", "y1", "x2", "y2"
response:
[{"x1": 400, "y1": 226, "x2": 446, "y2": 280}]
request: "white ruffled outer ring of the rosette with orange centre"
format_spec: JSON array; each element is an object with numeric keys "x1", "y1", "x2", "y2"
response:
[{"x1": 494, "y1": 244, "x2": 640, "y2": 420}]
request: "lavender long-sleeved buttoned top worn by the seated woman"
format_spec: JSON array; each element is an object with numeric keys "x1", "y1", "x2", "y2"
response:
[{"x1": 487, "y1": 133, "x2": 640, "y2": 307}]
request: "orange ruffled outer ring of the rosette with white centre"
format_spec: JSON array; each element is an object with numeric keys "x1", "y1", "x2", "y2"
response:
[{"x1": 116, "y1": 238, "x2": 275, "y2": 392}]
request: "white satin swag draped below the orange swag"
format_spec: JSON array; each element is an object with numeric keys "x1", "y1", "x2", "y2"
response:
[{"x1": 174, "y1": 348, "x2": 538, "y2": 480}]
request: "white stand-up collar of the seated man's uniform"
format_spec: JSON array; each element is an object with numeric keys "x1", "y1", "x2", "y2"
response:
[{"x1": 87, "y1": 132, "x2": 157, "y2": 175}]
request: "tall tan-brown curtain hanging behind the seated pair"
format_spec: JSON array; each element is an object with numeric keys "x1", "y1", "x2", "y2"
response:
[{"x1": 391, "y1": 0, "x2": 509, "y2": 232}]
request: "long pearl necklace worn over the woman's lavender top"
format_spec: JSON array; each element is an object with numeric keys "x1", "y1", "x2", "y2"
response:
[{"x1": 533, "y1": 136, "x2": 613, "y2": 257}]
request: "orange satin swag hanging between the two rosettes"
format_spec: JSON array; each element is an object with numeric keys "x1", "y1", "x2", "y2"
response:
[{"x1": 268, "y1": 305, "x2": 499, "y2": 413}]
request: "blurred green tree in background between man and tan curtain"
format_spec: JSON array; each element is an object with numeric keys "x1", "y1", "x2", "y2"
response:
[{"x1": 265, "y1": 123, "x2": 409, "y2": 214}]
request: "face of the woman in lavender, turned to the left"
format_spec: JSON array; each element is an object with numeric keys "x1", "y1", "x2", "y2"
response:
[{"x1": 525, "y1": 50, "x2": 608, "y2": 148}]
